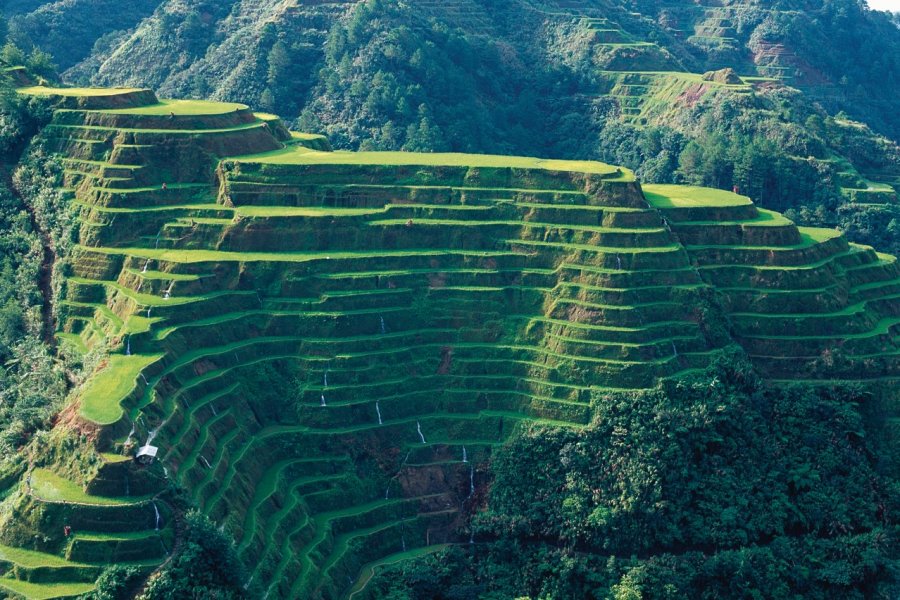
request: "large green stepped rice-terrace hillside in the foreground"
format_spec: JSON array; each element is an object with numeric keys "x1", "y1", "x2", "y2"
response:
[{"x1": 0, "y1": 88, "x2": 900, "y2": 598}]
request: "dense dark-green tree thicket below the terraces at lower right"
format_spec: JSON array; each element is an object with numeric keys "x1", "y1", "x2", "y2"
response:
[{"x1": 367, "y1": 354, "x2": 900, "y2": 600}]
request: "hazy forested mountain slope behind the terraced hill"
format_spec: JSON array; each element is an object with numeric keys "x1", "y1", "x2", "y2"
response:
[{"x1": 3, "y1": 0, "x2": 900, "y2": 264}]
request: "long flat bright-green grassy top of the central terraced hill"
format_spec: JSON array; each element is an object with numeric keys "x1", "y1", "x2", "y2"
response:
[{"x1": 230, "y1": 147, "x2": 633, "y2": 178}]
